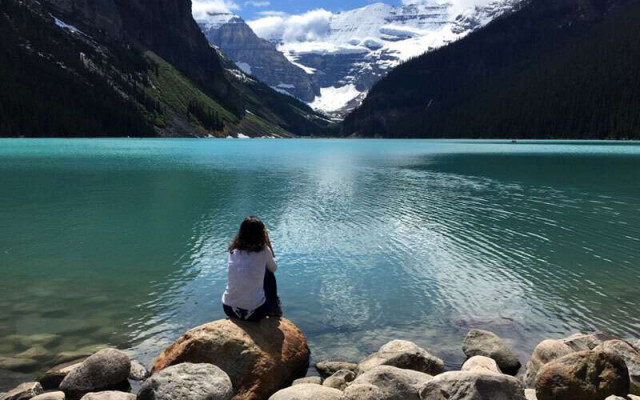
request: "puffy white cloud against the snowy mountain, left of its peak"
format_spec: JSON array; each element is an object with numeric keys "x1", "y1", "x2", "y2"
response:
[{"x1": 249, "y1": 9, "x2": 333, "y2": 42}]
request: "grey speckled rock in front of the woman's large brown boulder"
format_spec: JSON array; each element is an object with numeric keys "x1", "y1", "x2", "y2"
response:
[{"x1": 138, "y1": 363, "x2": 233, "y2": 400}]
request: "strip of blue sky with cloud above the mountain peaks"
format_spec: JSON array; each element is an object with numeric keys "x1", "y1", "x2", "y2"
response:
[{"x1": 193, "y1": 0, "x2": 401, "y2": 21}]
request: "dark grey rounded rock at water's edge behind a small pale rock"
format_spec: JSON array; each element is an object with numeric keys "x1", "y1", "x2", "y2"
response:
[{"x1": 462, "y1": 329, "x2": 521, "y2": 375}]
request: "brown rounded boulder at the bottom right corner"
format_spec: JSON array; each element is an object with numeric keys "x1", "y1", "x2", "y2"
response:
[{"x1": 536, "y1": 350, "x2": 629, "y2": 400}]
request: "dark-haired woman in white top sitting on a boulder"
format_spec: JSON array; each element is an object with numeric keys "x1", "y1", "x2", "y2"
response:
[{"x1": 222, "y1": 217, "x2": 282, "y2": 321}]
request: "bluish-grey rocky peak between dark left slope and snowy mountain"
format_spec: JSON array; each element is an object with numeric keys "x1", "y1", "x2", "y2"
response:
[{"x1": 197, "y1": 13, "x2": 320, "y2": 103}]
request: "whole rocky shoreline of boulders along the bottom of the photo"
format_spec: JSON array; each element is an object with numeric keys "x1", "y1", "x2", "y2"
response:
[{"x1": 0, "y1": 318, "x2": 640, "y2": 400}]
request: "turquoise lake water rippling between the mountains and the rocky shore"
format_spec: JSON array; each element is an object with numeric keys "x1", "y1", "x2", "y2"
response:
[{"x1": 0, "y1": 139, "x2": 640, "y2": 389}]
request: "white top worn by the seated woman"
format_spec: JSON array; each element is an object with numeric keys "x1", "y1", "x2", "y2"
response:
[{"x1": 222, "y1": 247, "x2": 278, "y2": 311}]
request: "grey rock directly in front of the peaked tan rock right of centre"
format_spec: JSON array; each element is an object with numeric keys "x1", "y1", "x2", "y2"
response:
[{"x1": 353, "y1": 365, "x2": 433, "y2": 400}]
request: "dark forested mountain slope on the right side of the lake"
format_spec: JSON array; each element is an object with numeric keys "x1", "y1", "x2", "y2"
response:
[{"x1": 343, "y1": 0, "x2": 640, "y2": 139}]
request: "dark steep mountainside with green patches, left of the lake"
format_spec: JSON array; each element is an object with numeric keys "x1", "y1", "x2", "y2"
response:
[{"x1": 0, "y1": 0, "x2": 331, "y2": 136}]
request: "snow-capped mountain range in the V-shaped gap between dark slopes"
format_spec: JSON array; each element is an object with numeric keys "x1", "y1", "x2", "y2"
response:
[{"x1": 199, "y1": 0, "x2": 520, "y2": 116}]
